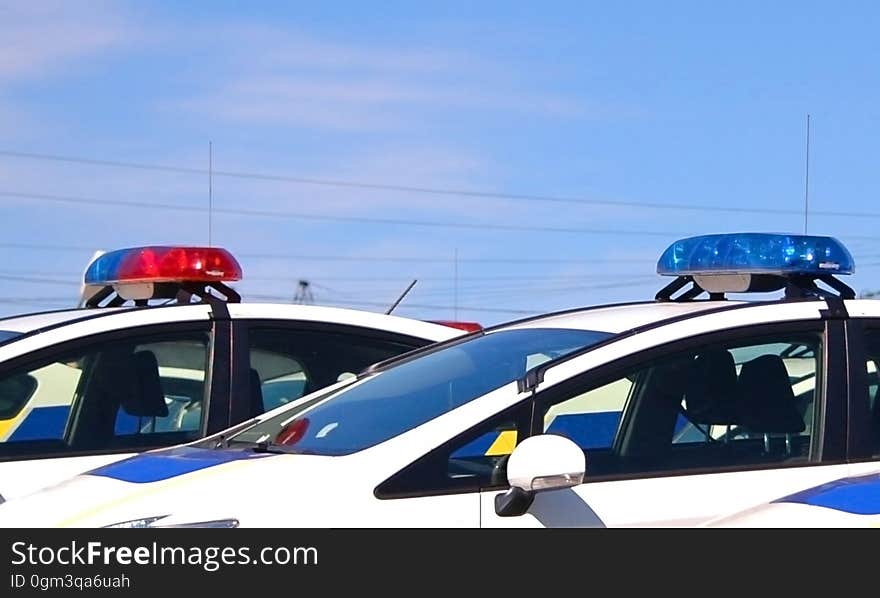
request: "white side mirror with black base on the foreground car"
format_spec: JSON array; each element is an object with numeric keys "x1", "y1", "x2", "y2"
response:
[{"x1": 495, "y1": 434, "x2": 587, "y2": 517}]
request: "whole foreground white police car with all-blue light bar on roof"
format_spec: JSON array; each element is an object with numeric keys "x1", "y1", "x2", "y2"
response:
[{"x1": 0, "y1": 233, "x2": 880, "y2": 527}]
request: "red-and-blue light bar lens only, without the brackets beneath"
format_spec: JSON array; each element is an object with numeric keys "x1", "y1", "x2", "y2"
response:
[{"x1": 84, "y1": 246, "x2": 242, "y2": 285}]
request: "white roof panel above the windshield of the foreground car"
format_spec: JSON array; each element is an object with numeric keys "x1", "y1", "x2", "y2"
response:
[{"x1": 496, "y1": 301, "x2": 744, "y2": 334}]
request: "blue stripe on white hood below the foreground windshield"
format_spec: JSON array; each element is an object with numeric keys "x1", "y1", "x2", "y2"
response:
[{"x1": 86, "y1": 446, "x2": 271, "y2": 484}]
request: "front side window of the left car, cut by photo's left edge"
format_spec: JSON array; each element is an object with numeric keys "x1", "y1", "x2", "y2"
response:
[{"x1": 0, "y1": 332, "x2": 209, "y2": 455}]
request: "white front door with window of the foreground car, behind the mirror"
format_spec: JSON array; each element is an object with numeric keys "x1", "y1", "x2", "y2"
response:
[{"x1": 481, "y1": 319, "x2": 847, "y2": 527}]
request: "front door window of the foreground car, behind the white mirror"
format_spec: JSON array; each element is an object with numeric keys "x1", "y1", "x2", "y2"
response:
[{"x1": 539, "y1": 333, "x2": 821, "y2": 477}]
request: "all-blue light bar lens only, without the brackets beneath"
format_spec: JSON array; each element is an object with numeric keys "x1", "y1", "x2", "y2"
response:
[{"x1": 657, "y1": 233, "x2": 855, "y2": 276}]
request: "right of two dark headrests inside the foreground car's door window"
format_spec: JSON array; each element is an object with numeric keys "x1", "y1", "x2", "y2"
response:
[{"x1": 738, "y1": 355, "x2": 806, "y2": 434}]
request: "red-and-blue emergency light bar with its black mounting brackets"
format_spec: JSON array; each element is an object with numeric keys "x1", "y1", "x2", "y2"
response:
[{"x1": 83, "y1": 245, "x2": 242, "y2": 307}]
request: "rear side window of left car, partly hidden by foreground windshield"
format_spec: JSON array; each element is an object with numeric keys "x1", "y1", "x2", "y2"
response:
[{"x1": 248, "y1": 327, "x2": 427, "y2": 415}]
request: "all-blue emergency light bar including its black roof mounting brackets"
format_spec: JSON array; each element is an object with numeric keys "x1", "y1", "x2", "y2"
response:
[{"x1": 657, "y1": 233, "x2": 855, "y2": 300}]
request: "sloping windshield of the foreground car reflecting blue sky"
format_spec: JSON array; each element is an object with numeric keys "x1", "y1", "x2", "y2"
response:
[{"x1": 230, "y1": 328, "x2": 611, "y2": 455}]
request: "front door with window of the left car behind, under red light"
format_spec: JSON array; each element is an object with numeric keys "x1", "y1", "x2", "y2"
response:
[{"x1": 0, "y1": 321, "x2": 223, "y2": 498}]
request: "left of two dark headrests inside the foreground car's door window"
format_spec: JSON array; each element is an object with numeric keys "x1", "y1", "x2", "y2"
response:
[{"x1": 684, "y1": 349, "x2": 738, "y2": 425}]
